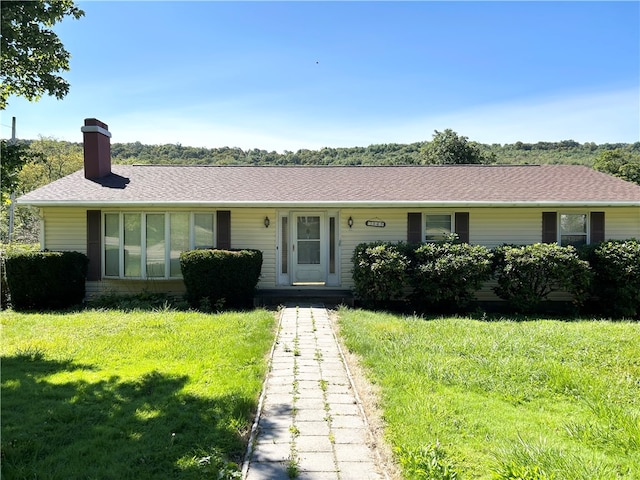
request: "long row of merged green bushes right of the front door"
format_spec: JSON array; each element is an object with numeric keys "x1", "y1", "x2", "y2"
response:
[{"x1": 352, "y1": 239, "x2": 640, "y2": 318}]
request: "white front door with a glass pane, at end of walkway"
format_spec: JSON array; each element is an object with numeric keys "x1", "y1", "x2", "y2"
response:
[{"x1": 291, "y1": 212, "x2": 327, "y2": 285}]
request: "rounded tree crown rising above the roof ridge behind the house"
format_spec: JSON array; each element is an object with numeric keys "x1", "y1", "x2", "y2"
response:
[{"x1": 422, "y1": 128, "x2": 491, "y2": 165}]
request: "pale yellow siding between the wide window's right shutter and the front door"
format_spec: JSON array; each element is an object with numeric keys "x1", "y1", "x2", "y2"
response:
[{"x1": 231, "y1": 208, "x2": 278, "y2": 288}]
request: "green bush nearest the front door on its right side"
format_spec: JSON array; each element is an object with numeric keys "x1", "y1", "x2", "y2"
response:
[{"x1": 351, "y1": 242, "x2": 409, "y2": 307}]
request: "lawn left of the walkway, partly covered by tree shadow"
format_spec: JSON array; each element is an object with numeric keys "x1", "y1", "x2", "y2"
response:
[{"x1": 0, "y1": 309, "x2": 275, "y2": 480}]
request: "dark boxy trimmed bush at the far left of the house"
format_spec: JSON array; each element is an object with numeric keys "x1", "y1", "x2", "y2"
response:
[{"x1": 6, "y1": 250, "x2": 89, "y2": 310}]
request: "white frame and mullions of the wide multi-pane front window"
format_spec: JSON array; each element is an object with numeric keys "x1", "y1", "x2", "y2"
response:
[{"x1": 100, "y1": 210, "x2": 218, "y2": 280}]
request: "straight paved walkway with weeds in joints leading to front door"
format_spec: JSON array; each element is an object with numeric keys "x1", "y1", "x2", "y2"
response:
[{"x1": 242, "y1": 306, "x2": 386, "y2": 480}]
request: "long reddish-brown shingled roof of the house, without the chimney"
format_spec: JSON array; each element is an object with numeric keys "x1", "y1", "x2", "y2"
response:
[{"x1": 18, "y1": 165, "x2": 640, "y2": 207}]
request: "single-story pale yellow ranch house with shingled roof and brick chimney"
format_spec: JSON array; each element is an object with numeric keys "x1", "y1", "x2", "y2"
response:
[{"x1": 18, "y1": 119, "x2": 640, "y2": 300}]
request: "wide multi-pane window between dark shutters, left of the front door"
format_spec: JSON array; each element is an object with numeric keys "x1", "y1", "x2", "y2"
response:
[{"x1": 104, "y1": 212, "x2": 215, "y2": 278}]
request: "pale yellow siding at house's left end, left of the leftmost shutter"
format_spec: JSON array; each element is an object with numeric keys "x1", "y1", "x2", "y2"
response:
[{"x1": 42, "y1": 207, "x2": 87, "y2": 254}]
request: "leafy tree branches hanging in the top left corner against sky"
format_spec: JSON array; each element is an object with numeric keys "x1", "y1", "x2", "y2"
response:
[{"x1": 0, "y1": 0, "x2": 84, "y2": 110}]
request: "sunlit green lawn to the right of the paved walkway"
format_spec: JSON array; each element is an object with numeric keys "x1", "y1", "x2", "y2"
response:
[{"x1": 339, "y1": 309, "x2": 640, "y2": 480}]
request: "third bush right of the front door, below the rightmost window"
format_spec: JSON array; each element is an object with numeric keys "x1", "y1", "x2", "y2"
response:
[{"x1": 493, "y1": 243, "x2": 591, "y2": 313}]
